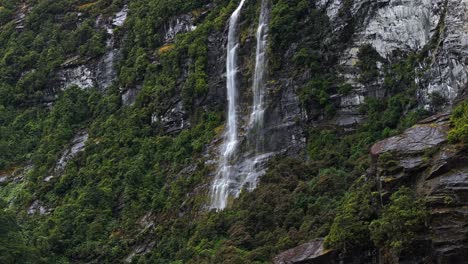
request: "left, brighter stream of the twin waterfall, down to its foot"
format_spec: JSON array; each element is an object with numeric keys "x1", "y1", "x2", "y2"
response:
[{"x1": 207, "y1": 0, "x2": 245, "y2": 209}]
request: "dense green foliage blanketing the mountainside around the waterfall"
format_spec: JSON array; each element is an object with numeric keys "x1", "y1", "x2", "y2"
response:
[{"x1": 0, "y1": 0, "x2": 442, "y2": 264}]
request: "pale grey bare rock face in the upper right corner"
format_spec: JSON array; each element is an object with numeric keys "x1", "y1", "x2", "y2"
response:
[{"x1": 317, "y1": 0, "x2": 468, "y2": 126}]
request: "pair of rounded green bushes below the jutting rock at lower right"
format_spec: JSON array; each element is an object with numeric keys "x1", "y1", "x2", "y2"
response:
[{"x1": 325, "y1": 184, "x2": 428, "y2": 256}]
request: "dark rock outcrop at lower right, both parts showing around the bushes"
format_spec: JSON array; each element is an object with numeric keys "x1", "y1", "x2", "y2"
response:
[{"x1": 274, "y1": 109, "x2": 468, "y2": 264}]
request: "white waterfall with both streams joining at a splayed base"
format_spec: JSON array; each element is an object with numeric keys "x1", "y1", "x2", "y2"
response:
[{"x1": 210, "y1": 0, "x2": 272, "y2": 210}]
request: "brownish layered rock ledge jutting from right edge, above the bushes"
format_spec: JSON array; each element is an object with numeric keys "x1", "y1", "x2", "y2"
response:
[{"x1": 371, "y1": 113, "x2": 468, "y2": 263}]
